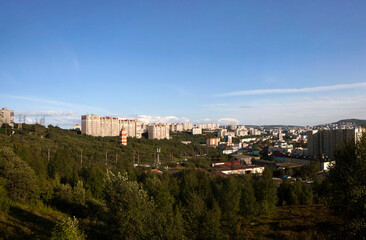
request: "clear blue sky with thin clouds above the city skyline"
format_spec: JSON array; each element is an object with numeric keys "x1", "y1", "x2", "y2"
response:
[{"x1": 0, "y1": 0, "x2": 366, "y2": 127}]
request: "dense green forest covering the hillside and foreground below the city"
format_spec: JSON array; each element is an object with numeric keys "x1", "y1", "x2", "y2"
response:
[{"x1": 0, "y1": 125, "x2": 366, "y2": 239}]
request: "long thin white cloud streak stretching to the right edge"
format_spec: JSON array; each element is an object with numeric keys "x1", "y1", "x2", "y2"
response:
[{"x1": 215, "y1": 82, "x2": 366, "y2": 97}]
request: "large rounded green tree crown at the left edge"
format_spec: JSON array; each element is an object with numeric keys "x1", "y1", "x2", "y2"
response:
[{"x1": 0, "y1": 148, "x2": 39, "y2": 201}]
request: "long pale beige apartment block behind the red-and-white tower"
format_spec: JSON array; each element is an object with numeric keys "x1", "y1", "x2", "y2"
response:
[{"x1": 81, "y1": 115, "x2": 142, "y2": 138}]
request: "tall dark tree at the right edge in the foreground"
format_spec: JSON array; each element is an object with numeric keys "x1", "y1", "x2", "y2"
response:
[{"x1": 326, "y1": 135, "x2": 366, "y2": 238}]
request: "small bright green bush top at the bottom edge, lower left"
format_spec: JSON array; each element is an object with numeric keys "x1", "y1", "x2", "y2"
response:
[{"x1": 51, "y1": 217, "x2": 86, "y2": 240}]
